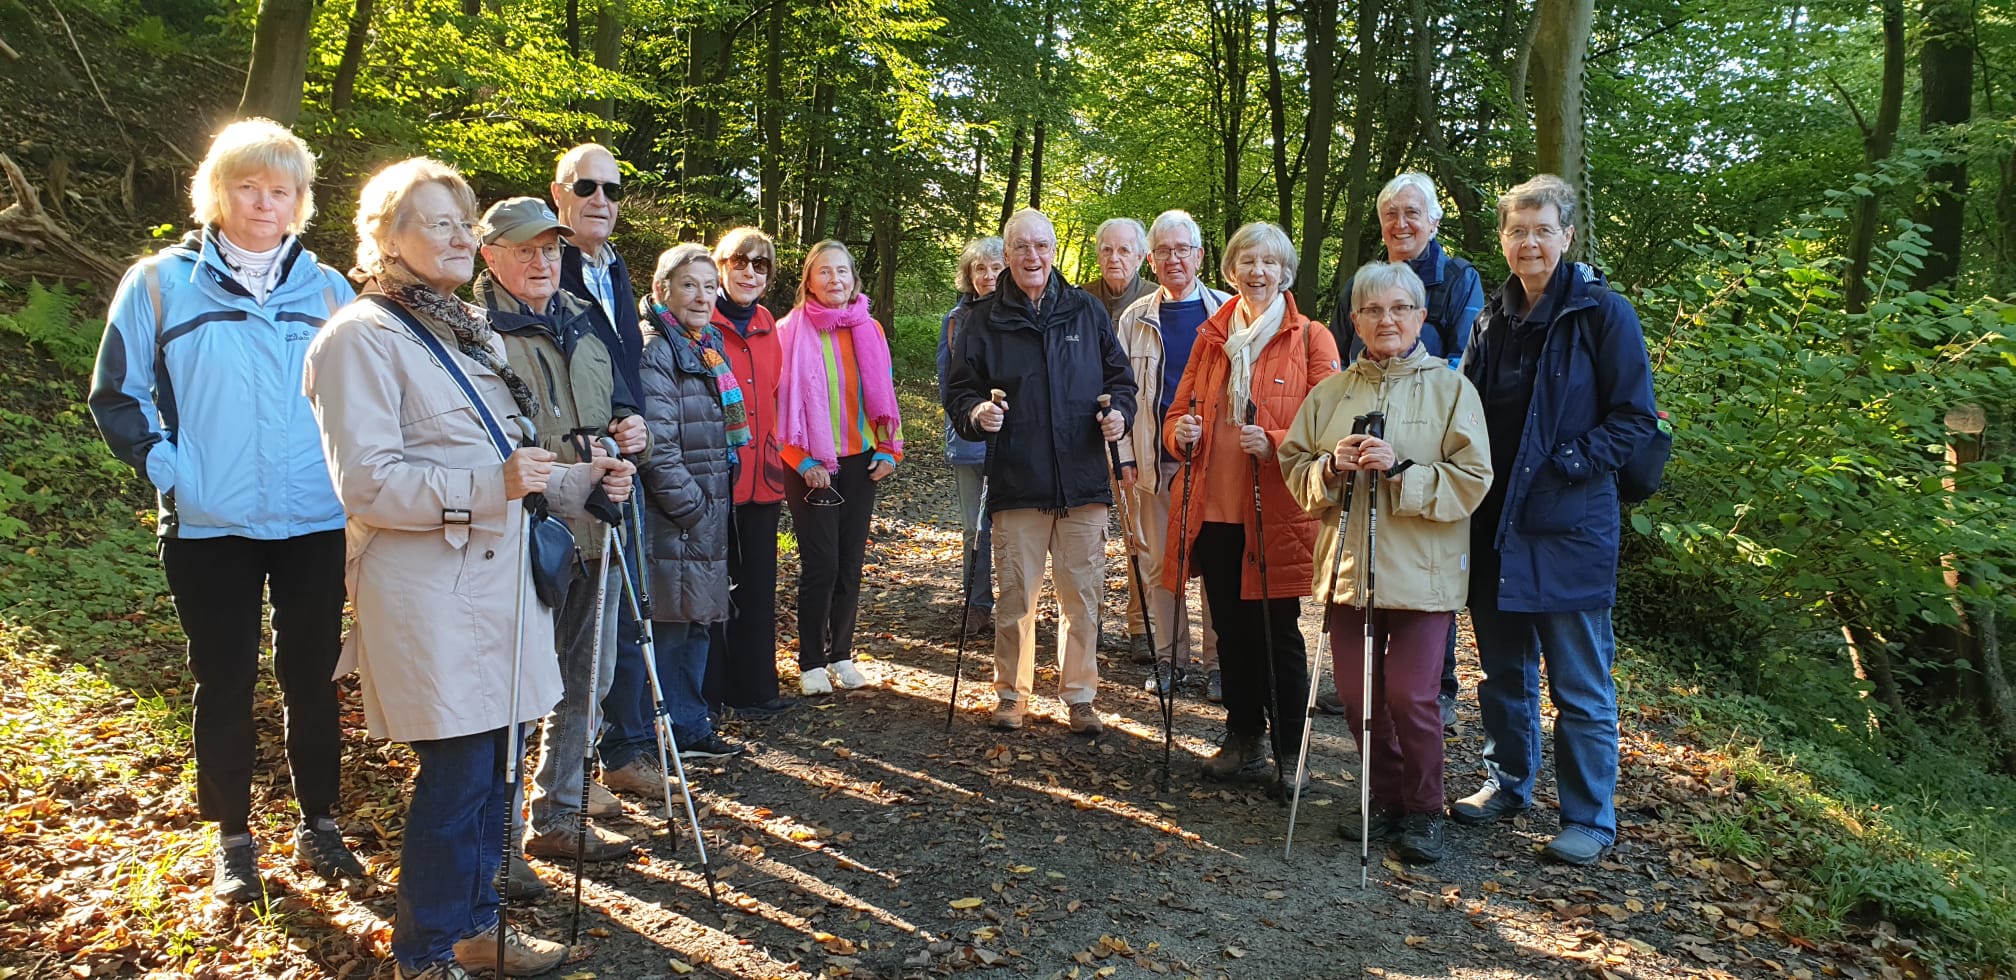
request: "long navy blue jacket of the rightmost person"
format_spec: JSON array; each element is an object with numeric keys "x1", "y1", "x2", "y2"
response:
[{"x1": 1464, "y1": 262, "x2": 1657, "y2": 613}]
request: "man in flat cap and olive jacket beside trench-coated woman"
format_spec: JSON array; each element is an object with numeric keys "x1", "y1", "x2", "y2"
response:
[{"x1": 474, "y1": 198, "x2": 645, "y2": 875}]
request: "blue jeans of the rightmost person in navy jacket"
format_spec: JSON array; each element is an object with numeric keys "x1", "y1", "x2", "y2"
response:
[{"x1": 1470, "y1": 605, "x2": 1617, "y2": 845}]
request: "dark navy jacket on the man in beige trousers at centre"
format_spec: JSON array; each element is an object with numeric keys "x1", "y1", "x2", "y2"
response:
[{"x1": 943, "y1": 270, "x2": 1135, "y2": 514}]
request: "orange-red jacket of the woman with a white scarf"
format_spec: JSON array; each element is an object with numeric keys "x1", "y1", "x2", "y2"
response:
[{"x1": 1161, "y1": 296, "x2": 1337, "y2": 599}]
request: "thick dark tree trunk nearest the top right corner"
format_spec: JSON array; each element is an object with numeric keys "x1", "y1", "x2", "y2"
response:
[{"x1": 1911, "y1": 0, "x2": 1974, "y2": 288}]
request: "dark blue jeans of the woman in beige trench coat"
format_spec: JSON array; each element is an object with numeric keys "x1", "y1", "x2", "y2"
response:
[{"x1": 391, "y1": 728, "x2": 524, "y2": 970}]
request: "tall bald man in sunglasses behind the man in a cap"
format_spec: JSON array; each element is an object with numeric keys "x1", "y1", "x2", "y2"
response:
[{"x1": 550, "y1": 143, "x2": 665, "y2": 801}]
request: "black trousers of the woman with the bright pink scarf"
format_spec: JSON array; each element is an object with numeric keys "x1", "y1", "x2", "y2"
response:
[{"x1": 778, "y1": 452, "x2": 875, "y2": 669}]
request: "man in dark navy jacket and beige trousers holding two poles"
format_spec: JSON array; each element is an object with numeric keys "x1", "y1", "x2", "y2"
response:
[{"x1": 943, "y1": 208, "x2": 1135, "y2": 736}]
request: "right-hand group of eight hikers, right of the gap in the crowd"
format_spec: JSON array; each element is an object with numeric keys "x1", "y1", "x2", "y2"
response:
[{"x1": 939, "y1": 173, "x2": 1655, "y2": 863}]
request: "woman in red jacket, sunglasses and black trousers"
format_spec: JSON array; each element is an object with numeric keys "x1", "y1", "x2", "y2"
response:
[{"x1": 706, "y1": 228, "x2": 798, "y2": 718}]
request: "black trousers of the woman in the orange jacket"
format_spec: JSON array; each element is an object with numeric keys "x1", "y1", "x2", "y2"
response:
[{"x1": 1195, "y1": 522, "x2": 1308, "y2": 760}]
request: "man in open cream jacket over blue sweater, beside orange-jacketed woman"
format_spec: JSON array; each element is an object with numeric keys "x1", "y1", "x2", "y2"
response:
[{"x1": 1113, "y1": 212, "x2": 1232, "y2": 704}]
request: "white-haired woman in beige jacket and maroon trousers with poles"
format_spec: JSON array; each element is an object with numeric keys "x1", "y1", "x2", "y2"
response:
[{"x1": 1280, "y1": 262, "x2": 1492, "y2": 863}]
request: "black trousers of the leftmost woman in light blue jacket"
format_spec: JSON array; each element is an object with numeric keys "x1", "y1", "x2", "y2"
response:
[{"x1": 161, "y1": 530, "x2": 343, "y2": 833}]
